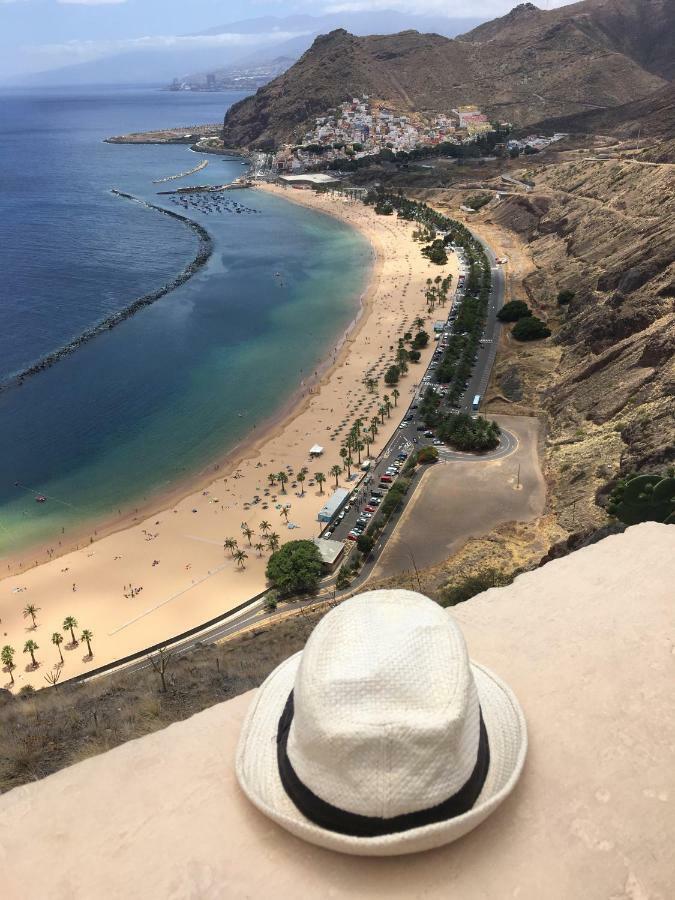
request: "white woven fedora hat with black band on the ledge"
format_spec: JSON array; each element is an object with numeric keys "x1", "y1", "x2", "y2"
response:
[{"x1": 236, "y1": 590, "x2": 527, "y2": 856}]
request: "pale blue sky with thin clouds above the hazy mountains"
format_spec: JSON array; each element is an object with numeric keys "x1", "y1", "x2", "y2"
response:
[{"x1": 0, "y1": 0, "x2": 571, "y2": 81}]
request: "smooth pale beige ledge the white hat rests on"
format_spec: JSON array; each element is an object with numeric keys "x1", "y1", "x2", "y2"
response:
[{"x1": 0, "y1": 523, "x2": 675, "y2": 900}]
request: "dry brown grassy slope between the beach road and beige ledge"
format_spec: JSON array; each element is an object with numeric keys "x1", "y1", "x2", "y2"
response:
[{"x1": 0, "y1": 607, "x2": 327, "y2": 792}]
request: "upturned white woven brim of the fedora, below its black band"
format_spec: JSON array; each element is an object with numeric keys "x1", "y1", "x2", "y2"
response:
[{"x1": 236, "y1": 653, "x2": 527, "y2": 856}]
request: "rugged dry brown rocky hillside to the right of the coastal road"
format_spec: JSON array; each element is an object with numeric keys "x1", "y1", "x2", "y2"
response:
[{"x1": 482, "y1": 159, "x2": 675, "y2": 526}]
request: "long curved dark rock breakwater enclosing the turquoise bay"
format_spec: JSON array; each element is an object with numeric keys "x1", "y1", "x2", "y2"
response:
[{"x1": 0, "y1": 188, "x2": 213, "y2": 391}]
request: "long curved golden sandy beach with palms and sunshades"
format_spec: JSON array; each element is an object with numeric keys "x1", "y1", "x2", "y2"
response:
[{"x1": 0, "y1": 186, "x2": 457, "y2": 689}]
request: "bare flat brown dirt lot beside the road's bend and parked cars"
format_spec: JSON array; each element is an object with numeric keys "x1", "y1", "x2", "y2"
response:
[{"x1": 372, "y1": 416, "x2": 546, "y2": 579}]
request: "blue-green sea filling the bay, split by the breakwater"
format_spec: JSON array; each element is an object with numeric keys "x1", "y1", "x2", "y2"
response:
[{"x1": 0, "y1": 88, "x2": 371, "y2": 556}]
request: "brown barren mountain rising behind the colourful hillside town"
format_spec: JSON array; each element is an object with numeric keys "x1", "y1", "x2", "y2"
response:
[{"x1": 224, "y1": 0, "x2": 673, "y2": 147}]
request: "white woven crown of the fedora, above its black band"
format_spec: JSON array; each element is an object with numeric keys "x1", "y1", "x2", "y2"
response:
[{"x1": 288, "y1": 591, "x2": 480, "y2": 818}]
